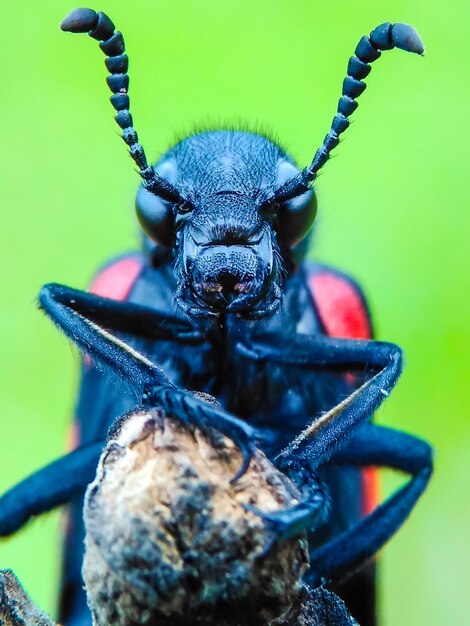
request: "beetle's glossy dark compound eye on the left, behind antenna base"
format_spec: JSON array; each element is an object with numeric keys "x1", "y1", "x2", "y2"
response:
[{"x1": 135, "y1": 161, "x2": 176, "y2": 248}]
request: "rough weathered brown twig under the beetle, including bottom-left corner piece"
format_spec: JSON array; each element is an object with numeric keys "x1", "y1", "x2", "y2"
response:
[{"x1": 0, "y1": 400, "x2": 355, "y2": 626}]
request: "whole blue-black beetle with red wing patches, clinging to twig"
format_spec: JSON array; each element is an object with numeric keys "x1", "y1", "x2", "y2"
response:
[{"x1": 0, "y1": 9, "x2": 432, "y2": 626}]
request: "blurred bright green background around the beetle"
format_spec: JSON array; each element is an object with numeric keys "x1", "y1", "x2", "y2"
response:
[{"x1": 0, "y1": 0, "x2": 470, "y2": 626}]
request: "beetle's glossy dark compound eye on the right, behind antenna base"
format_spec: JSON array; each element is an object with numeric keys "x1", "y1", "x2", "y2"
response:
[{"x1": 277, "y1": 161, "x2": 317, "y2": 248}]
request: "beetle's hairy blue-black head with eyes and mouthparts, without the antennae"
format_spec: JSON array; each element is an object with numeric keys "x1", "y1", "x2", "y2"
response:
[{"x1": 136, "y1": 131, "x2": 316, "y2": 318}]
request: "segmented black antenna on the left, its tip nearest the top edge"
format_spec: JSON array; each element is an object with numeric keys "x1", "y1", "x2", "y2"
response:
[{"x1": 60, "y1": 9, "x2": 183, "y2": 202}]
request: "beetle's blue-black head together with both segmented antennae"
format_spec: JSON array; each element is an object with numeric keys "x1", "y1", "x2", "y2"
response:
[{"x1": 61, "y1": 9, "x2": 424, "y2": 318}]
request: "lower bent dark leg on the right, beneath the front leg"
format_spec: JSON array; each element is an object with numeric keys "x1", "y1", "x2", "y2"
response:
[{"x1": 310, "y1": 424, "x2": 432, "y2": 585}]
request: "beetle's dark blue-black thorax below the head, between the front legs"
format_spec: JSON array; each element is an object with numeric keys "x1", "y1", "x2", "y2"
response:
[{"x1": 130, "y1": 258, "x2": 346, "y2": 448}]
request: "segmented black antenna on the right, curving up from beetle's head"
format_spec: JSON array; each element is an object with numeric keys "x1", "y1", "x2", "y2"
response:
[{"x1": 272, "y1": 22, "x2": 424, "y2": 203}]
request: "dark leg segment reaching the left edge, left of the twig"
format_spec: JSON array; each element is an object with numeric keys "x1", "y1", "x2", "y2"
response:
[{"x1": 0, "y1": 442, "x2": 104, "y2": 537}]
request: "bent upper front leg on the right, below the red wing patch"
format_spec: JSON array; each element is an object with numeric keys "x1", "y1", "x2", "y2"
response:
[{"x1": 236, "y1": 334, "x2": 402, "y2": 469}]
